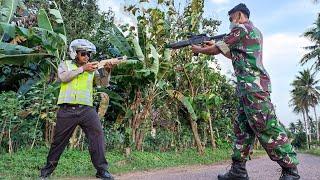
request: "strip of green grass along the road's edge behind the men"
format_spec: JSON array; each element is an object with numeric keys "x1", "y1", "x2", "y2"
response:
[{"x1": 0, "y1": 148, "x2": 265, "y2": 179}]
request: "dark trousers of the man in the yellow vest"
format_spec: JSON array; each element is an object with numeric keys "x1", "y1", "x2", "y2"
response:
[{"x1": 41, "y1": 105, "x2": 108, "y2": 175}]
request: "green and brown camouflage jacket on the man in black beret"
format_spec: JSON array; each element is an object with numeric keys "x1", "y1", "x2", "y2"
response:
[{"x1": 216, "y1": 21, "x2": 271, "y2": 96}]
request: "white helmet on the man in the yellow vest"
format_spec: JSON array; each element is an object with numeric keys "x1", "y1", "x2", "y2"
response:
[{"x1": 69, "y1": 39, "x2": 96, "y2": 59}]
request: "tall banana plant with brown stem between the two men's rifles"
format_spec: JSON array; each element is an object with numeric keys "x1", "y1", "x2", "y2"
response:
[{"x1": 104, "y1": 6, "x2": 171, "y2": 149}]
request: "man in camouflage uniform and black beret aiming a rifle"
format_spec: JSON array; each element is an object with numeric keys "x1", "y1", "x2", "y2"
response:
[{"x1": 192, "y1": 4, "x2": 300, "y2": 180}]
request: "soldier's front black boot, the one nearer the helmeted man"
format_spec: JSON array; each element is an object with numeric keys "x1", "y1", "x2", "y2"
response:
[{"x1": 218, "y1": 160, "x2": 249, "y2": 180}]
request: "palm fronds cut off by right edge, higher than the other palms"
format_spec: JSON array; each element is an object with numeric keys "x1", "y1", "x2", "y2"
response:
[{"x1": 300, "y1": 13, "x2": 320, "y2": 70}]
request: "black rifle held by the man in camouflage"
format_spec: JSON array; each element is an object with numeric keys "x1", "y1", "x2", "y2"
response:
[{"x1": 166, "y1": 34, "x2": 227, "y2": 49}]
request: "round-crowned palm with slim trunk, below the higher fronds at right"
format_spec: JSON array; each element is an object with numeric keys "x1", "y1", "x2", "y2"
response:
[{"x1": 291, "y1": 69, "x2": 320, "y2": 148}]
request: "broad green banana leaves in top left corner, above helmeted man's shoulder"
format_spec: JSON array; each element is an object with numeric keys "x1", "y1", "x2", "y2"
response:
[{"x1": 0, "y1": 0, "x2": 67, "y2": 68}]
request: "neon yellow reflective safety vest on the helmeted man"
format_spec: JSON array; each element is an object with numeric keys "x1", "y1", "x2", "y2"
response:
[{"x1": 58, "y1": 60, "x2": 94, "y2": 106}]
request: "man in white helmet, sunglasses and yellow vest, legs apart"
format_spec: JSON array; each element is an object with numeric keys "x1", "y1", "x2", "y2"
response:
[{"x1": 40, "y1": 39, "x2": 113, "y2": 180}]
